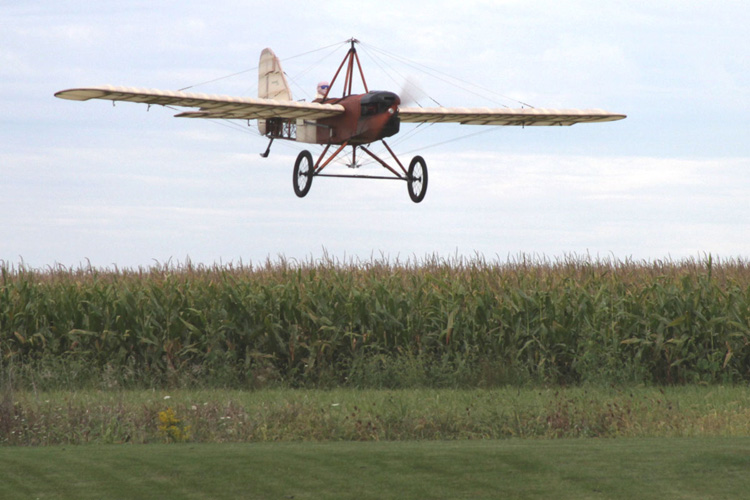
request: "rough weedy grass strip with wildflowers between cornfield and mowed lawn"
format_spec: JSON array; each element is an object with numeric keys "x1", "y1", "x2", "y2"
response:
[{"x1": 0, "y1": 386, "x2": 750, "y2": 446}]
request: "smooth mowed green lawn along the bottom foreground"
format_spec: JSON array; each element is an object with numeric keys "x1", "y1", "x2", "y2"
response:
[{"x1": 0, "y1": 437, "x2": 750, "y2": 500}]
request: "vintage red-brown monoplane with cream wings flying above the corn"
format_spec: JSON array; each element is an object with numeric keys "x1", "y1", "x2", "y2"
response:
[{"x1": 55, "y1": 39, "x2": 625, "y2": 203}]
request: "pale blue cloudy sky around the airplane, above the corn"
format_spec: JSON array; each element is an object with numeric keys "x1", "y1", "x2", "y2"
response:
[{"x1": 0, "y1": 0, "x2": 750, "y2": 268}]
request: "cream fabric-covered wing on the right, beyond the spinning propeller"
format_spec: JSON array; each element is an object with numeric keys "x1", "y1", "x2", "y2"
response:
[{"x1": 399, "y1": 108, "x2": 626, "y2": 126}]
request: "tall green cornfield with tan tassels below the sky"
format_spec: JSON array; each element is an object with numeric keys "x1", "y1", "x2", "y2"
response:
[{"x1": 0, "y1": 256, "x2": 750, "y2": 387}]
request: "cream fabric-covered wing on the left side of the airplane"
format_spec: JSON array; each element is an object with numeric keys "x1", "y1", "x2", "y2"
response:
[{"x1": 55, "y1": 86, "x2": 344, "y2": 120}]
